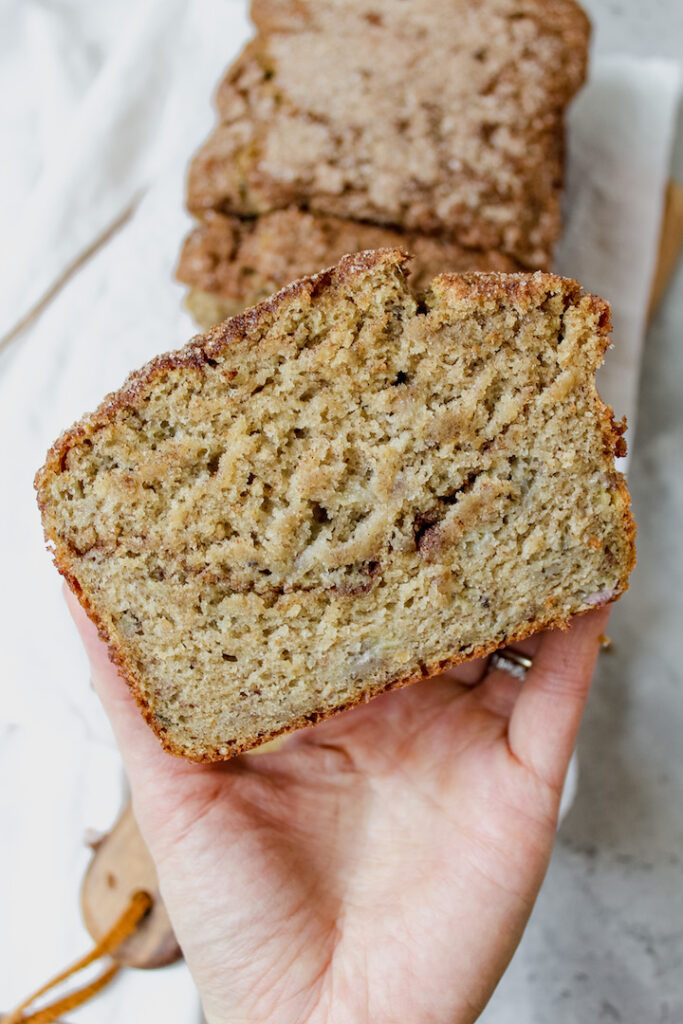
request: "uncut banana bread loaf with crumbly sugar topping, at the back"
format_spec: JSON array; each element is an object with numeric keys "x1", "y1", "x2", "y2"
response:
[{"x1": 187, "y1": 0, "x2": 589, "y2": 267}]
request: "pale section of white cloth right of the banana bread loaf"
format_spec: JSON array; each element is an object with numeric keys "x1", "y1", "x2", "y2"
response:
[{"x1": 555, "y1": 56, "x2": 681, "y2": 448}]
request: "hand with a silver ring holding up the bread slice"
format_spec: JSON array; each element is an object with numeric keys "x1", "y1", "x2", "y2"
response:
[{"x1": 70, "y1": 597, "x2": 608, "y2": 1024}]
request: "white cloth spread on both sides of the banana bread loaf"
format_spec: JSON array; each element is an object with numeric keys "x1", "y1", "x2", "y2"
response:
[{"x1": 0, "y1": 0, "x2": 679, "y2": 1024}]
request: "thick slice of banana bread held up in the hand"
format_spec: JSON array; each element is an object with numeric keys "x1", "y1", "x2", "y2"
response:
[{"x1": 36, "y1": 250, "x2": 634, "y2": 761}]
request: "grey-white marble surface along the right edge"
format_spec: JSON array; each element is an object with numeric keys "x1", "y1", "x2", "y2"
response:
[{"x1": 481, "y1": 0, "x2": 683, "y2": 1024}]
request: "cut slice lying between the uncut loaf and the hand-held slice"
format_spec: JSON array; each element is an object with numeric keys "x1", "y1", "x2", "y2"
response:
[{"x1": 176, "y1": 208, "x2": 521, "y2": 328}]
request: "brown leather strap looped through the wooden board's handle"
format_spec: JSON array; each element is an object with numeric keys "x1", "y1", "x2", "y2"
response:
[{"x1": 2, "y1": 892, "x2": 152, "y2": 1024}]
